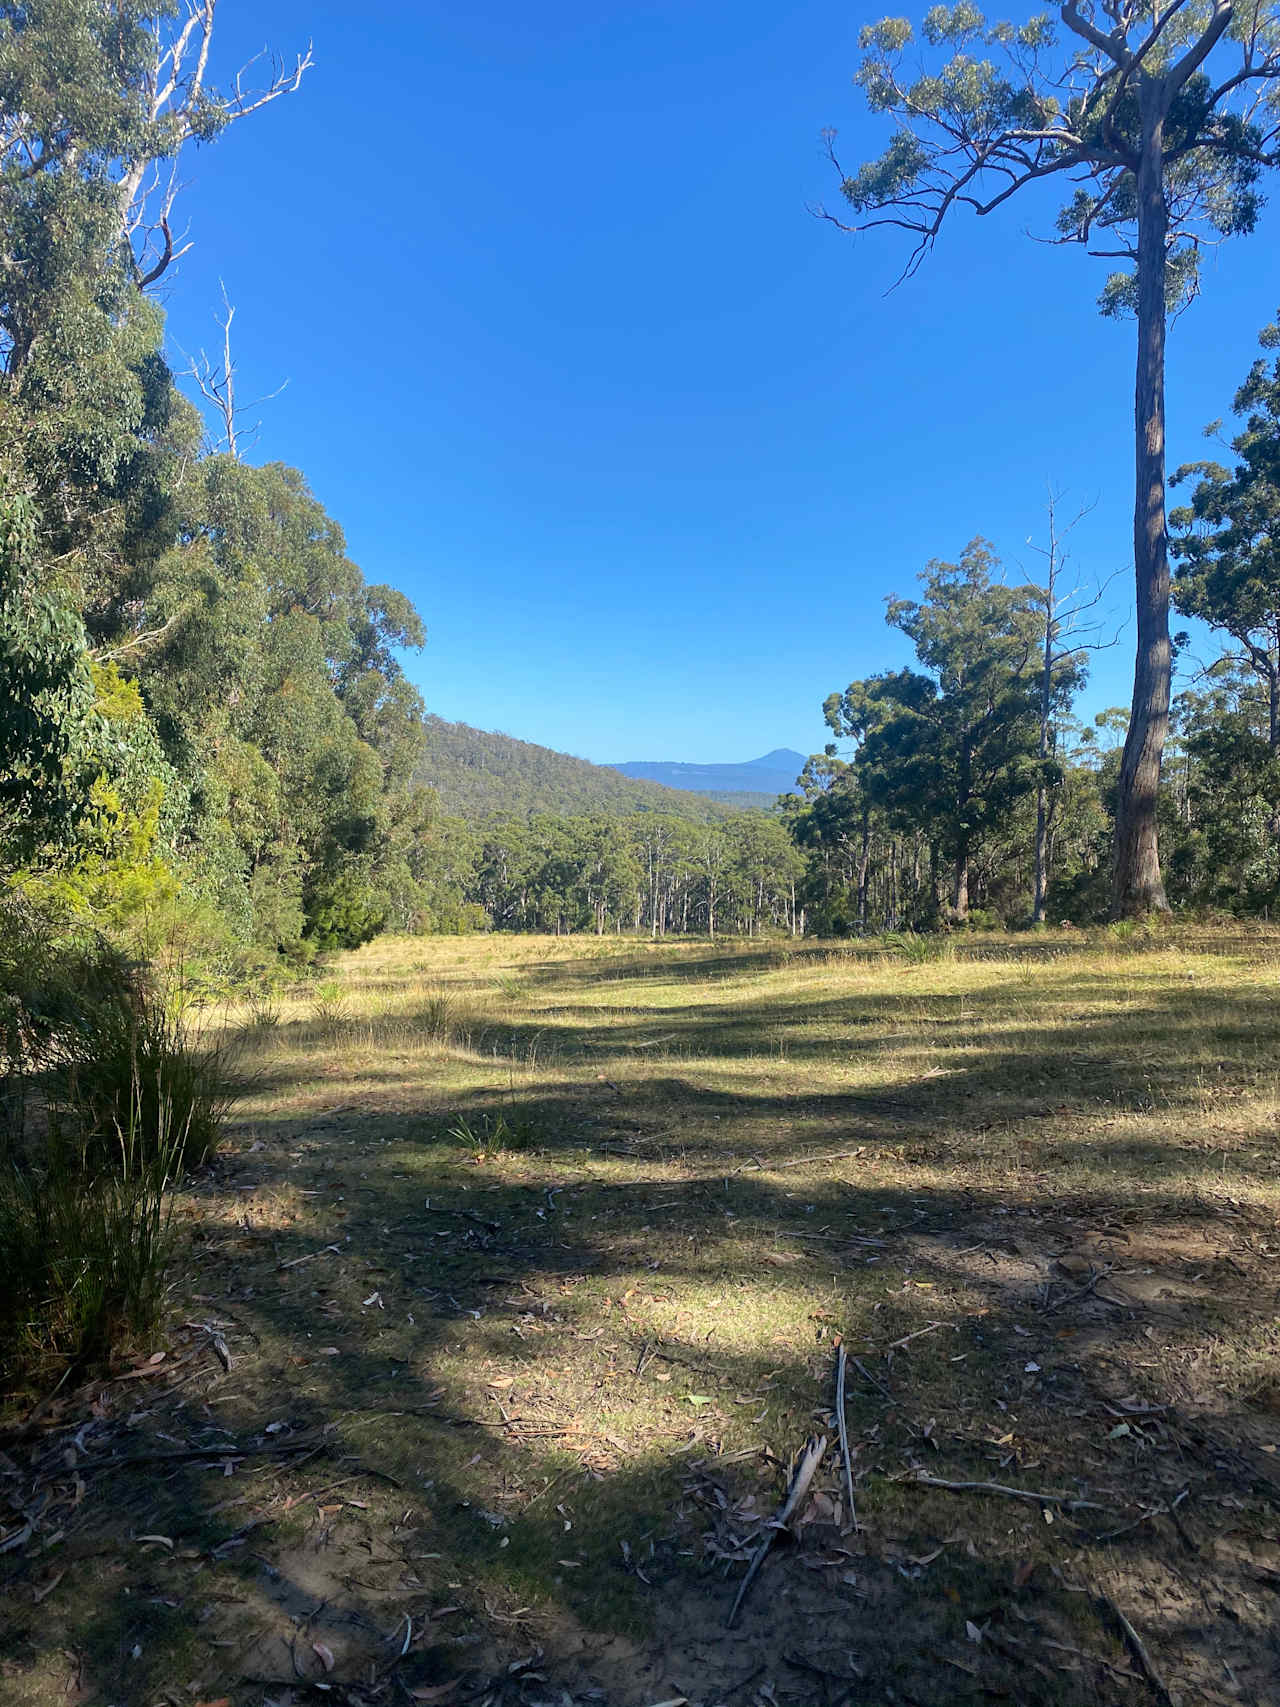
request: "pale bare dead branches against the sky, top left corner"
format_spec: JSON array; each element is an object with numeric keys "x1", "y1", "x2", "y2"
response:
[{"x1": 118, "y1": 0, "x2": 314, "y2": 290}]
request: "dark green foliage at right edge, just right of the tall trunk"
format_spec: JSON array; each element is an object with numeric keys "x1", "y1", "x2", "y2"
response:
[{"x1": 1169, "y1": 308, "x2": 1280, "y2": 754}]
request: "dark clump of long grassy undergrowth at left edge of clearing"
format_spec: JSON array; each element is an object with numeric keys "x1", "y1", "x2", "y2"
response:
[{"x1": 0, "y1": 900, "x2": 230, "y2": 1398}]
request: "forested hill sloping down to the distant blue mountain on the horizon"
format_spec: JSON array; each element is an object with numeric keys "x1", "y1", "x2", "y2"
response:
[{"x1": 415, "y1": 717, "x2": 761, "y2": 821}]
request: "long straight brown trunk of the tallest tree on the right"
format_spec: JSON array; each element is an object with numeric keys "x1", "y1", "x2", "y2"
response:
[{"x1": 1111, "y1": 96, "x2": 1171, "y2": 918}]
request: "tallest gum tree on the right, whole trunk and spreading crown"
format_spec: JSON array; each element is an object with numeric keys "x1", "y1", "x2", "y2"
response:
[{"x1": 828, "y1": 0, "x2": 1280, "y2": 915}]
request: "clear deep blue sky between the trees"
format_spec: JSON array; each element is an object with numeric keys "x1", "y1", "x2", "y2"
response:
[{"x1": 166, "y1": 0, "x2": 1280, "y2": 761}]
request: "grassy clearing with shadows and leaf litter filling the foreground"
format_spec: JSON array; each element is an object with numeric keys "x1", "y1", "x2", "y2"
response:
[{"x1": 0, "y1": 932, "x2": 1280, "y2": 1707}]
